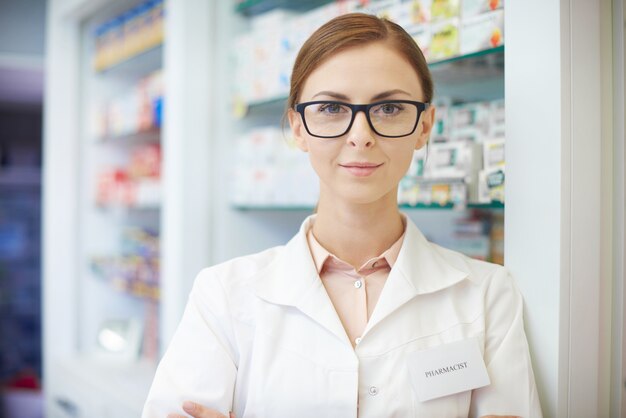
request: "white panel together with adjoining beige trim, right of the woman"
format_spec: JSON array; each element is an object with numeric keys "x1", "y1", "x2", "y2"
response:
[{"x1": 505, "y1": 0, "x2": 612, "y2": 417}]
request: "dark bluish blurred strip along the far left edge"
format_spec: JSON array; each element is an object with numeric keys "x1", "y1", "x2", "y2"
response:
[{"x1": 0, "y1": 0, "x2": 46, "y2": 417}]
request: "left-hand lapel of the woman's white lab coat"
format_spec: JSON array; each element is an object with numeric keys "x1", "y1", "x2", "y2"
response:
[{"x1": 254, "y1": 216, "x2": 350, "y2": 344}]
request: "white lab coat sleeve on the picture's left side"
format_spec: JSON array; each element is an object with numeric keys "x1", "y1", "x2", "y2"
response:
[{"x1": 142, "y1": 269, "x2": 237, "y2": 418}]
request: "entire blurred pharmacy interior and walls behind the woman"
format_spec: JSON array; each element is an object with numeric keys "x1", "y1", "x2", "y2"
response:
[{"x1": 0, "y1": 0, "x2": 626, "y2": 418}]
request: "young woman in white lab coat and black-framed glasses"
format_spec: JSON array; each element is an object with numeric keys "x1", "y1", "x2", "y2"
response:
[{"x1": 143, "y1": 14, "x2": 541, "y2": 418}]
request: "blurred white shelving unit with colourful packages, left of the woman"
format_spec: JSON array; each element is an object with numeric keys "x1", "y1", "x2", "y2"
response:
[{"x1": 44, "y1": 0, "x2": 211, "y2": 417}]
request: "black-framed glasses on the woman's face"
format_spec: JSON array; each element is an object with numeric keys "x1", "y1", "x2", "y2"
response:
[{"x1": 296, "y1": 100, "x2": 429, "y2": 138}]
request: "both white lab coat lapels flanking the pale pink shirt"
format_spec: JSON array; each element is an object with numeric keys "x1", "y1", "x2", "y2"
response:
[{"x1": 254, "y1": 215, "x2": 468, "y2": 344}]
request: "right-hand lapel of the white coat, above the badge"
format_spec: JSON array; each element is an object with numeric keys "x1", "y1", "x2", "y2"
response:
[{"x1": 364, "y1": 217, "x2": 468, "y2": 335}]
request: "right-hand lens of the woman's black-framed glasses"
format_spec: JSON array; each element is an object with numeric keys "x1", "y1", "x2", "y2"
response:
[{"x1": 370, "y1": 102, "x2": 419, "y2": 136}]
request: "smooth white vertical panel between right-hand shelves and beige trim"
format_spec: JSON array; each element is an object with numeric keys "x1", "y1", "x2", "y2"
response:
[{"x1": 505, "y1": 0, "x2": 567, "y2": 417}]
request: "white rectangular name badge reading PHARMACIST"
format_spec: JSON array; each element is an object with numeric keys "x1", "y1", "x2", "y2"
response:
[{"x1": 407, "y1": 338, "x2": 491, "y2": 402}]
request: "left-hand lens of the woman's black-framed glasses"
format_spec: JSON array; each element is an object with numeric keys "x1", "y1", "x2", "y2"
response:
[{"x1": 304, "y1": 103, "x2": 352, "y2": 137}]
